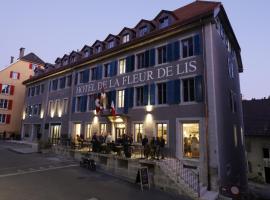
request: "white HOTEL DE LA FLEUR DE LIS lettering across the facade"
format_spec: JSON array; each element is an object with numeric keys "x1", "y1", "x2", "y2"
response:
[{"x1": 76, "y1": 58, "x2": 201, "y2": 95}]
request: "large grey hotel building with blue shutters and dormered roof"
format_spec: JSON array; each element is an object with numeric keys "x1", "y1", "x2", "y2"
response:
[{"x1": 21, "y1": 1, "x2": 247, "y2": 196}]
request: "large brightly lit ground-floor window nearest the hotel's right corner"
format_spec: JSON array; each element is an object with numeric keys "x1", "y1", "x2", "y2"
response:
[{"x1": 182, "y1": 123, "x2": 200, "y2": 158}]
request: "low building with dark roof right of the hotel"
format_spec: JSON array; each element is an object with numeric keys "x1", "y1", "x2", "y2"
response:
[{"x1": 243, "y1": 98, "x2": 270, "y2": 183}]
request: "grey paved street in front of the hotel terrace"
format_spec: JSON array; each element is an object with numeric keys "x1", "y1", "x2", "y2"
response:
[{"x1": 0, "y1": 142, "x2": 190, "y2": 200}]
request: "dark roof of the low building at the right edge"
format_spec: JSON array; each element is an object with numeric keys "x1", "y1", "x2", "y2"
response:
[{"x1": 242, "y1": 98, "x2": 270, "y2": 136}]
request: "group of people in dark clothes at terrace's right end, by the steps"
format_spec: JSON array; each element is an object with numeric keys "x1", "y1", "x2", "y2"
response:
[{"x1": 142, "y1": 135, "x2": 165, "y2": 159}]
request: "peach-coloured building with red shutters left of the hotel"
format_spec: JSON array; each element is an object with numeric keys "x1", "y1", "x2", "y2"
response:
[{"x1": 0, "y1": 48, "x2": 44, "y2": 137}]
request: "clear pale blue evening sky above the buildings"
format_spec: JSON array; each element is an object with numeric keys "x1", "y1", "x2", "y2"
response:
[{"x1": 0, "y1": 0, "x2": 270, "y2": 99}]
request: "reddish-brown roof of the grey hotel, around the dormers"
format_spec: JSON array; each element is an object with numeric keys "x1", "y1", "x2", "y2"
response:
[{"x1": 24, "y1": 1, "x2": 237, "y2": 84}]
